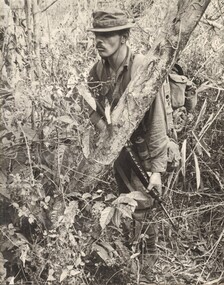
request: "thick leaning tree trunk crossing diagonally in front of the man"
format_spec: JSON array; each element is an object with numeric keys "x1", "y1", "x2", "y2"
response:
[{"x1": 71, "y1": 0, "x2": 210, "y2": 190}]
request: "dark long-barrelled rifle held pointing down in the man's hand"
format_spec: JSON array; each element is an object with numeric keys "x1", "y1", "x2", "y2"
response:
[{"x1": 125, "y1": 146, "x2": 181, "y2": 233}]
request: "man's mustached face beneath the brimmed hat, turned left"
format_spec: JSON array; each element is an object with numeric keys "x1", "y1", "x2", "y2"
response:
[{"x1": 95, "y1": 32, "x2": 121, "y2": 58}]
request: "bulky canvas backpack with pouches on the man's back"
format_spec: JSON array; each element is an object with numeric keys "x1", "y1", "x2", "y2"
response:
[{"x1": 162, "y1": 64, "x2": 197, "y2": 171}]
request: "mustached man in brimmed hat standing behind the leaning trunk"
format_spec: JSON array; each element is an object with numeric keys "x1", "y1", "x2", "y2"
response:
[{"x1": 88, "y1": 8, "x2": 168, "y2": 282}]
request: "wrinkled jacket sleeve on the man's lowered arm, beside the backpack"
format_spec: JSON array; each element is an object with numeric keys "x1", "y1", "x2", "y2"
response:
[{"x1": 144, "y1": 89, "x2": 168, "y2": 172}]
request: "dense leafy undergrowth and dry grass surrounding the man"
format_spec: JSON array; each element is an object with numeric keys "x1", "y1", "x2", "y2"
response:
[{"x1": 0, "y1": 0, "x2": 224, "y2": 285}]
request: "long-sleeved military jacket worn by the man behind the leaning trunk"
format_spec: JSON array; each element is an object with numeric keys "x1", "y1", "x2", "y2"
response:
[{"x1": 88, "y1": 48, "x2": 168, "y2": 172}]
